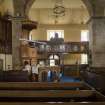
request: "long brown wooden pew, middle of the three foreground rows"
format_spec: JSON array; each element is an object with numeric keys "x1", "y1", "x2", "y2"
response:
[{"x1": 0, "y1": 90, "x2": 95, "y2": 98}]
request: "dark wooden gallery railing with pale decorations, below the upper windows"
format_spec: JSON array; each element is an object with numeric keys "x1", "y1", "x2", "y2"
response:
[{"x1": 38, "y1": 42, "x2": 89, "y2": 53}]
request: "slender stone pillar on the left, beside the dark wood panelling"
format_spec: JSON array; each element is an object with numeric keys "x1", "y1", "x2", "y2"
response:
[{"x1": 12, "y1": 17, "x2": 22, "y2": 70}]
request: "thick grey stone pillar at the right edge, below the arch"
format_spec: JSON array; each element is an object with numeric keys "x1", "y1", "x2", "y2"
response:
[{"x1": 89, "y1": 17, "x2": 105, "y2": 67}]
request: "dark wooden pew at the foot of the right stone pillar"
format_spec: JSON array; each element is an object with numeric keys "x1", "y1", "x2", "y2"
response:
[{"x1": 81, "y1": 67, "x2": 105, "y2": 95}]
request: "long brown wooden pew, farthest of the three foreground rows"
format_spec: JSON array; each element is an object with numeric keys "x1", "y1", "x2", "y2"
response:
[{"x1": 0, "y1": 82, "x2": 90, "y2": 90}]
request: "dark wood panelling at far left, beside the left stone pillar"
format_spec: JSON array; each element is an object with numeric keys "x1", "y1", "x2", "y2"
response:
[{"x1": 0, "y1": 18, "x2": 12, "y2": 54}]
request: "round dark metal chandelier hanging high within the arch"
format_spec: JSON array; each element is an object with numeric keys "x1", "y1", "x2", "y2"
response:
[{"x1": 53, "y1": 0, "x2": 65, "y2": 21}]
